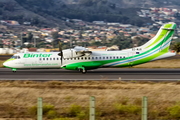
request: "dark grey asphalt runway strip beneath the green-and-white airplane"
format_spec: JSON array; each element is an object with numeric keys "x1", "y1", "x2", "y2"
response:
[{"x1": 0, "y1": 68, "x2": 180, "y2": 81}]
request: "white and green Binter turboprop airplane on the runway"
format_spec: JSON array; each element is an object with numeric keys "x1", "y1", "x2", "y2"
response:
[{"x1": 3, "y1": 22, "x2": 176, "y2": 73}]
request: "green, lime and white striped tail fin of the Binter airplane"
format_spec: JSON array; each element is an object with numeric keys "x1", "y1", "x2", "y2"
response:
[{"x1": 140, "y1": 22, "x2": 176, "y2": 52}]
